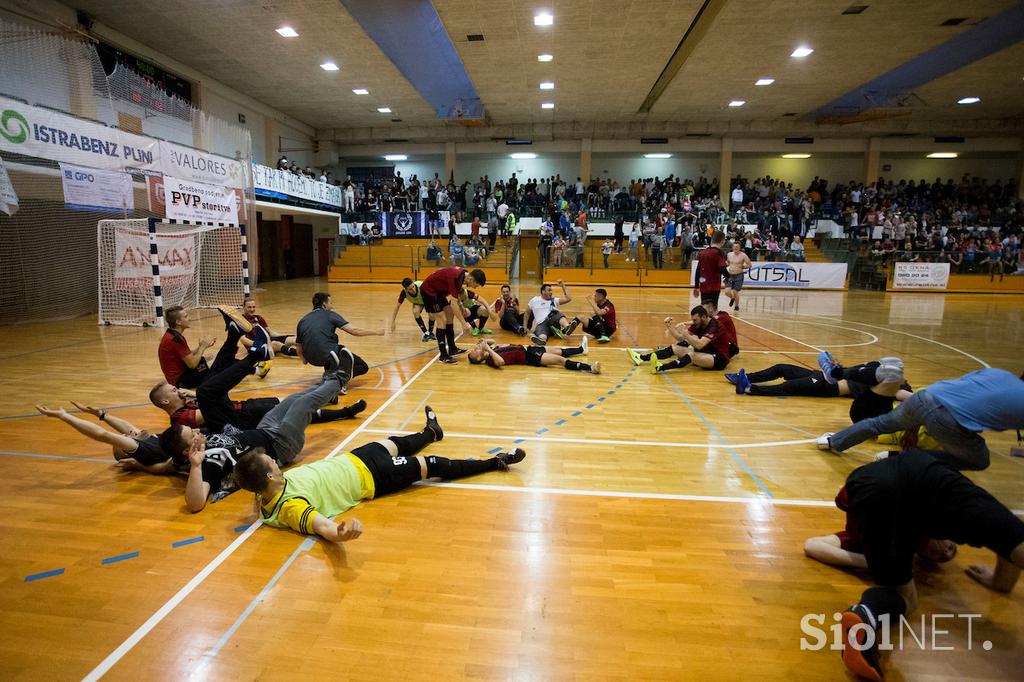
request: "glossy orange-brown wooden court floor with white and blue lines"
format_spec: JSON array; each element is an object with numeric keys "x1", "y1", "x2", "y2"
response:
[{"x1": 0, "y1": 281, "x2": 1024, "y2": 681}]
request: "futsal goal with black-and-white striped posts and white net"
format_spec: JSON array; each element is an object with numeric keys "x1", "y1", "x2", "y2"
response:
[{"x1": 96, "y1": 218, "x2": 249, "y2": 327}]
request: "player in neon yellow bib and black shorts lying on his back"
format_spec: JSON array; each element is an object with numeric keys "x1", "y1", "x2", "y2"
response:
[{"x1": 234, "y1": 406, "x2": 526, "y2": 542}]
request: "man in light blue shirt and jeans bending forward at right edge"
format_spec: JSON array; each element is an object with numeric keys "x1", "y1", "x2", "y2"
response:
[{"x1": 817, "y1": 368, "x2": 1024, "y2": 471}]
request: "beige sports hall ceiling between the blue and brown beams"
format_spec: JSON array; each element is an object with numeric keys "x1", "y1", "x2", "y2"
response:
[{"x1": 75, "y1": 0, "x2": 1024, "y2": 143}]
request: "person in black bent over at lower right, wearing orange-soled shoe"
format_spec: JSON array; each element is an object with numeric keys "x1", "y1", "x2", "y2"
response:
[{"x1": 815, "y1": 451, "x2": 1024, "y2": 682}]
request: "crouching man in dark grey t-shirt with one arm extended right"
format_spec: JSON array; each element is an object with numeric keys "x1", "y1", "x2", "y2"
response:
[{"x1": 295, "y1": 292, "x2": 384, "y2": 393}]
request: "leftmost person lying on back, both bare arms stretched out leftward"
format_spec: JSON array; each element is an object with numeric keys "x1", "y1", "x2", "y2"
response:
[{"x1": 36, "y1": 400, "x2": 182, "y2": 474}]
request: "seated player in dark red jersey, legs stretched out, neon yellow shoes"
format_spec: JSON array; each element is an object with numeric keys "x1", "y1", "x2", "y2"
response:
[{"x1": 628, "y1": 305, "x2": 739, "y2": 374}]
